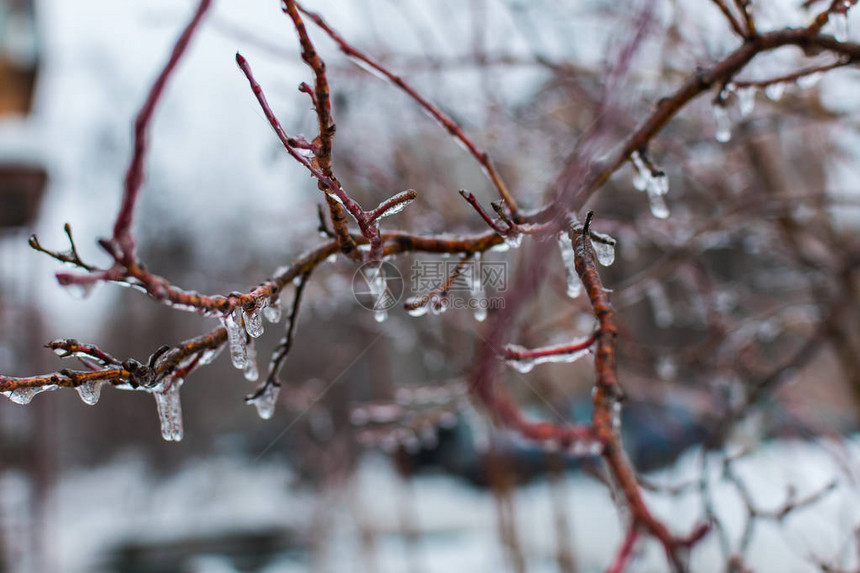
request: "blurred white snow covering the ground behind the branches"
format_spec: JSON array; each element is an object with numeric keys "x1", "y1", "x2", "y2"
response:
[{"x1": 0, "y1": 438, "x2": 860, "y2": 573}]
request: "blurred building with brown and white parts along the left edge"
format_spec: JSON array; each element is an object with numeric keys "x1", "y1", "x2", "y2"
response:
[{"x1": 0, "y1": 0, "x2": 52, "y2": 571}]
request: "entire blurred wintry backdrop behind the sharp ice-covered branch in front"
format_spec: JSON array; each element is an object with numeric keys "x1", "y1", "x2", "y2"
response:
[{"x1": 0, "y1": 0, "x2": 860, "y2": 573}]
